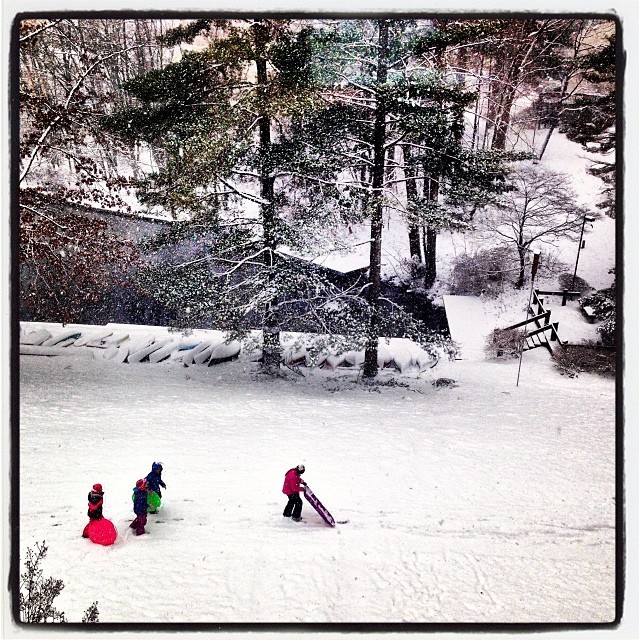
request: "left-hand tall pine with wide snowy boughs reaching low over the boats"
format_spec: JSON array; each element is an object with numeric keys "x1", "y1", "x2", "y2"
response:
[{"x1": 104, "y1": 20, "x2": 382, "y2": 371}]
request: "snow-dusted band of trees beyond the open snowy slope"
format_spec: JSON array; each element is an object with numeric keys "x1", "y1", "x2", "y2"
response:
[{"x1": 19, "y1": 18, "x2": 616, "y2": 378}]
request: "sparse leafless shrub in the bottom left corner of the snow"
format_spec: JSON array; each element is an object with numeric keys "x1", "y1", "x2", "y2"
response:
[{"x1": 19, "y1": 540, "x2": 99, "y2": 623}]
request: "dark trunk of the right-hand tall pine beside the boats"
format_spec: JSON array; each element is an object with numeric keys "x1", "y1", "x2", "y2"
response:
[{"x1": 362, "y1": 20, "x2": 389, "y2": 378}]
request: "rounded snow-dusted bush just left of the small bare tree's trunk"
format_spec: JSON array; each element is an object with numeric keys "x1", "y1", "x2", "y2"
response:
[{"x1": 451, "y1": 247, "x2": 514, "y2": 298}]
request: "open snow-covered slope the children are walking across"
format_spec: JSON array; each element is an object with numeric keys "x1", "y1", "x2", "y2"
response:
[{"x1": 20, "y1": 340, "x2": 615, "y2": 623}]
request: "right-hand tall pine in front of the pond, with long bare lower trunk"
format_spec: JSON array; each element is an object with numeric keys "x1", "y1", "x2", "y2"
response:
[{"x1": 302, "y1": 20, "x2": 462, "y2": 378}]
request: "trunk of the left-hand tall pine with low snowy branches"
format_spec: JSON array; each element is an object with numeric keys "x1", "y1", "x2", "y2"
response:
[{"x1": 254, "y1": 23, "x2": 281, "y2": 373}]
